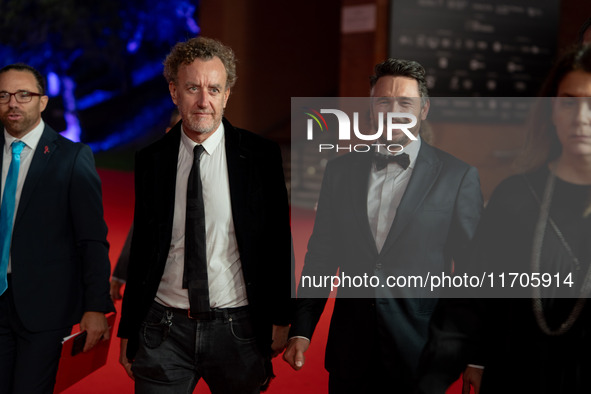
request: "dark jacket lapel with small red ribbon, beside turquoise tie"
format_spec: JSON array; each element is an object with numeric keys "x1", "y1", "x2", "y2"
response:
[{"x1": 14, "y1": 125, "x2": 58, "y2": 227}]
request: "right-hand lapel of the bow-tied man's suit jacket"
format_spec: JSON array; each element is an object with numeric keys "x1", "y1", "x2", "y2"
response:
[{"x1": 381, "y1": 141, "x2": 441, "y2": 255}]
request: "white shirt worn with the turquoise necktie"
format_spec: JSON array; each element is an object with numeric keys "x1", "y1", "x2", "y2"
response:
[{"x1": 0, "y1": 120, "x2": 45, "y2": 273}]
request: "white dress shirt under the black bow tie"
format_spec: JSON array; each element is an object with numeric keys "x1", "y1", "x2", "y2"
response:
[{"x1": 367, "y1": 137, "x2": 421, "y2": 252}]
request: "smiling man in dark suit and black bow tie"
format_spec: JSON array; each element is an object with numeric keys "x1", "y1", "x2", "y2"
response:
[{"x1": 284, "y1": 59, "x2": 482, "y2": 393}]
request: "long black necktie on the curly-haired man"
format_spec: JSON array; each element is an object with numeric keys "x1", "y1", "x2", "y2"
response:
[{"x1": 183, "y1": 145, "x2": 209, "y2": 313}]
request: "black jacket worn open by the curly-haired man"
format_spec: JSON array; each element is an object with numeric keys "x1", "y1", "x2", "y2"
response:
[{"x1": 118, "y1": 119, "x2": 291, "y2": 359}]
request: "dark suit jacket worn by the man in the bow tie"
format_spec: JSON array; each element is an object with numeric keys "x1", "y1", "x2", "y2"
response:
[{"x1": 290, "y1": 141, "x2": 482, "y2": 378}]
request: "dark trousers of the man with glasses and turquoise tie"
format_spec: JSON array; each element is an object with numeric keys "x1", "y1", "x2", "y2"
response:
[{"x1": 0, "y1": 280, "x2": 72, "y2": 394}]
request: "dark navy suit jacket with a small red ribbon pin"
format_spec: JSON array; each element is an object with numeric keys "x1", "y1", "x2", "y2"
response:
[{"x1": 0, "y1": 125, "x2": 115, "y2": 331}]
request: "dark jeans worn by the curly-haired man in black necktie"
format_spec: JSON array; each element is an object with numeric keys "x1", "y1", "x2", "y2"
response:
[{"x1": 132, "y1": 302, "x2": 266, "y2": 394}]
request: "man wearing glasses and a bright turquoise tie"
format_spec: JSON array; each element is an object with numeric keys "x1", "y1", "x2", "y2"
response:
[{"x1": 0, "y1": 64, "x2": 114, "y2": 393}]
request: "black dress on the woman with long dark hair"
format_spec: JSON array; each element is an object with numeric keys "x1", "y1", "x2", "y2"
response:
[{"x1": 473, "y1": 168, "x2": 591, "y2": 394}]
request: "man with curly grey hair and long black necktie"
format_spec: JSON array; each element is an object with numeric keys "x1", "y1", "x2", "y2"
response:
[{"x1": 119, "y1": 37, "x2": 291, "y2": 393}]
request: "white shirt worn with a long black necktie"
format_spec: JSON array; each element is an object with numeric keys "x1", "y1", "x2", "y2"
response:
[{"x1": 156, "y1": 123, "x2": 248, "y2": 309}]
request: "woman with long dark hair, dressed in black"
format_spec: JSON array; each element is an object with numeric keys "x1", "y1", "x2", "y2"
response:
[{"x1": 420, "y1": 45, "x2": 591, "y2": 394}]
